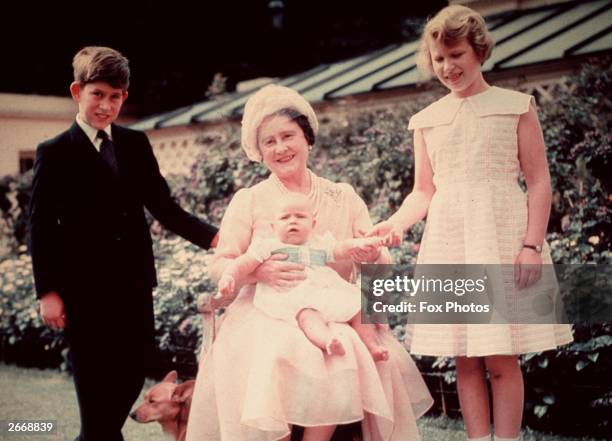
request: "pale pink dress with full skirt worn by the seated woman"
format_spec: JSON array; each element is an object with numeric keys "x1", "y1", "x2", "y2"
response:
[{"x1": 187, "y1": 173, "x2": 433, "y2": 441}]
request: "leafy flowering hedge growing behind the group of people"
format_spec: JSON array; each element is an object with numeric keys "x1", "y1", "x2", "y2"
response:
[{"x1": 0, "y1": 59, "x2": 612, "y2": 435}]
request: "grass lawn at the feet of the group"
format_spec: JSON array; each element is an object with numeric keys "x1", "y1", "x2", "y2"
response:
[{"x1": 0, "y1": 363, "x2": 604, "y2": 441}]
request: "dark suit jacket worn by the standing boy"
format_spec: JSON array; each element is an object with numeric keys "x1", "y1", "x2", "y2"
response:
[{"x1": 30, "y1": 123, "x2": 217, "y2": 322}]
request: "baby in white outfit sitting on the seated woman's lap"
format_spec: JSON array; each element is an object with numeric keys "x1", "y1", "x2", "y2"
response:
[{"x1": 219, "y1": 194, "x2": 388, "y2": 361}]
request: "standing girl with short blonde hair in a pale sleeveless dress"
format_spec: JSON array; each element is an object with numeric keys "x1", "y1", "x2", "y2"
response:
[{"x1": 369, "y1": 5, "x2": 572, "y2": 441}]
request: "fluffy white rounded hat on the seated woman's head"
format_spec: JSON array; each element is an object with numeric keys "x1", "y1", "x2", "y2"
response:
[{"x1": 242, "y1": 84, "x2": 319, "y2": 162}]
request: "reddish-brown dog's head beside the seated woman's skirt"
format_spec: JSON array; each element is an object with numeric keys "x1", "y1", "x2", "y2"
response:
[{"x1": 130, "y1": 371, "x2": 195, "y2": 423}]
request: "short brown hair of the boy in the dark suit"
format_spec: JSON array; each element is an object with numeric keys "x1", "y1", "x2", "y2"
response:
[{"x1": 72, "y1": 46, "x2": 130, "y2": 90}]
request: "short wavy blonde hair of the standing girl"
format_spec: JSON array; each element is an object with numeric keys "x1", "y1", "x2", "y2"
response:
[{"x1": 416, "y1": 5, "x2": 495, "y2": 74}]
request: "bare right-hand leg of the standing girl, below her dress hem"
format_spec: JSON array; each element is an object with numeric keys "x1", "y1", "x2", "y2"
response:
[{"x1": 485, "y1": 355, "x2": 525, "y2": 439}]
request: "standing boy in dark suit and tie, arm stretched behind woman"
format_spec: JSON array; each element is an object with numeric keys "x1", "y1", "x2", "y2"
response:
[{"x1": 30, "y1": 47, "x2": 217, "y2": 441}]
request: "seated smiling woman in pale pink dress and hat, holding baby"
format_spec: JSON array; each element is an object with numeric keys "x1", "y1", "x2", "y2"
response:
[{"x1": 187, "y1": 85, "x2": 432, "y2": 441}]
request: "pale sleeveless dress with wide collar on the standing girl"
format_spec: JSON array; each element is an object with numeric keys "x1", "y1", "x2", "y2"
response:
[{"x1": 406, "y1": 87, "x2": 572, "y2": 356}]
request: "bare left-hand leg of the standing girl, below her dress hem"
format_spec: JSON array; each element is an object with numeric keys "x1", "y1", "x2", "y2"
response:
[{"x1": 456, "y1": 357, "x2": 491, "y2": 439}]
